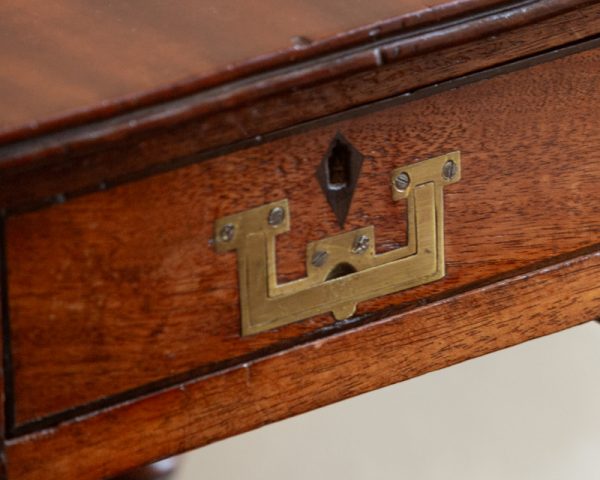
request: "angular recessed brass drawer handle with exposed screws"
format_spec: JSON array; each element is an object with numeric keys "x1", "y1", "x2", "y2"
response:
[{"x1": 215, "y1": 152, "x2": 460, "y2": 335}]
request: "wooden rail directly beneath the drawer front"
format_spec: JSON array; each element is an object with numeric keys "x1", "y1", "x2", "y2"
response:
[{"x1": 8, "y1": 251, "x2": 600, "y2": 480}]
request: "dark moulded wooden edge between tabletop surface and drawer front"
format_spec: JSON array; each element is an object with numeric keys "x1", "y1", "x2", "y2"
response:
[{"x1": 0, "y1": 0, "x2": 600, "y2": 211}]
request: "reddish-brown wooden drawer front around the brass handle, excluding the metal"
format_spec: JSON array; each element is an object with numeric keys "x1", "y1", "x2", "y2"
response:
[{"x1": 6, "y1": 50, "x2": 600, "y2": 427}]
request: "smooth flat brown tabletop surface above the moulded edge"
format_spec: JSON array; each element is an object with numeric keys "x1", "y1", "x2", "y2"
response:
[{"x1": 0, "y1": 0, "x2": 500, "y2": 135}]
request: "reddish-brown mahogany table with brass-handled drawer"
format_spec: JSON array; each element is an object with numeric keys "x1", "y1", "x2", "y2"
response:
[{"x1": 0, "y1": 0, "x2": 600, "y2": 480}]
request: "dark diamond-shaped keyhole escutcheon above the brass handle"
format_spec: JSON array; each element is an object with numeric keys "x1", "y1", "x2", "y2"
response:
[{"x1": 317, "y1": 132, "x2": 363, "y2": 228}]
